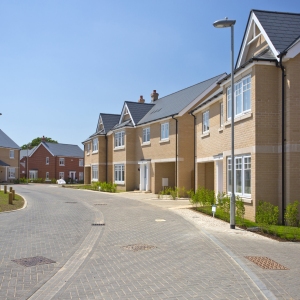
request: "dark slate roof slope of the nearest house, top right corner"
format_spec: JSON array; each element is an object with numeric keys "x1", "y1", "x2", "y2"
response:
[{"x1": 252, "y1": 9, "x2": 300, "y2": 53}]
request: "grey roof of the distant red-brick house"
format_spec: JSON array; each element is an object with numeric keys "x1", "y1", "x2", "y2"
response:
[{"x1": 30, "y1": 142, "x2": 84, "y2": 158}]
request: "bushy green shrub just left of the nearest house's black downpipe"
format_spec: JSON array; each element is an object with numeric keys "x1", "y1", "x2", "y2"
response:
[{"x1": 256, "y1": 201, "x2": 279, "y2": 225}]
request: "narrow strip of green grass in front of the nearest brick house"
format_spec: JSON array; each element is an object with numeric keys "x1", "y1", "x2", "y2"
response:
[{"x1": 193, "y1": 206, "x2": 300, "y2": 242}]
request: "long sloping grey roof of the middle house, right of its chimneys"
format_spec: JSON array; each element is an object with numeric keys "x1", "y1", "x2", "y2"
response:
[{"x1": 138, "y1": 73, "x2": 225, "y2": 125}]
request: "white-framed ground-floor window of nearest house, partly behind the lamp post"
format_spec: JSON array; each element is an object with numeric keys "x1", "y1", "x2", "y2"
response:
[{"x1": 227, "y1": 155, "x2": 251, "y2": 196}]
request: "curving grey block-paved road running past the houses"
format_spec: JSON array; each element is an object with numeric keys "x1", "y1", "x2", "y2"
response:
[{"x1": 0, "y1": 184, "x2": 300, "y2": 300}]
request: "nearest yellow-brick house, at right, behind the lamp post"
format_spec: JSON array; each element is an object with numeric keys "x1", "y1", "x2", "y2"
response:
[{"x1": 192, "y1": 10, "x2": 300, "y2": 220}]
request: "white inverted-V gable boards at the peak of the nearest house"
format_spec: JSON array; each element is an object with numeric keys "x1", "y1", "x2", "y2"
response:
[{"x1": 236, "y1": 12, "x2": 279, "y2": 68}]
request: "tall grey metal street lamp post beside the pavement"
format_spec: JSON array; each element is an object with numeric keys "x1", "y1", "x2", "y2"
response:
[{"x1": 213, "y1": 18, "x2": 236, "y2": 229}]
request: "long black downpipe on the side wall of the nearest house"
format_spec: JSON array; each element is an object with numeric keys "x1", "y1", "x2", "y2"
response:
[{"x1": 277, "y1": 51, "x2": 287, "y2": 225}]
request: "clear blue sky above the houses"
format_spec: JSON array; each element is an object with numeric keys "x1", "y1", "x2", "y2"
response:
[{"x1": 0, "y1": 0, "x2": 300, "y2": 147}]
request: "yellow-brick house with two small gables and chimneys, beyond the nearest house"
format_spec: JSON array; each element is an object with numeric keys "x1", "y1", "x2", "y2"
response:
[{"x1": 83, "y1": 74, "x2": 226, "y2": 193}]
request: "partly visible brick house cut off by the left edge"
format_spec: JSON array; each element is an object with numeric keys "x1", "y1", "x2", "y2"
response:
[{"x1": 0, "y1": 129, "x2": 20, "y2": 182}]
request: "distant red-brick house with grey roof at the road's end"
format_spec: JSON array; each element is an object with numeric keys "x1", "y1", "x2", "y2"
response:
[{"x1": 21, "y1": 141, "x2": 84, "y2": 182}]
